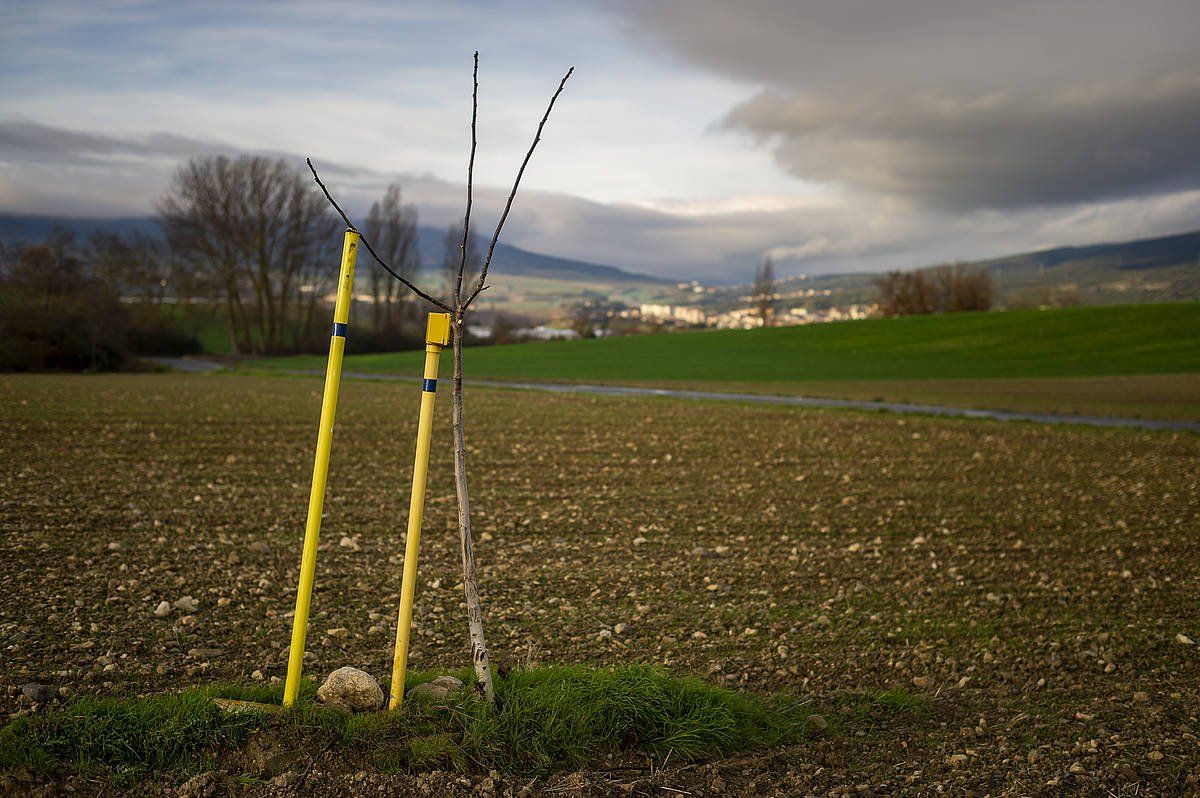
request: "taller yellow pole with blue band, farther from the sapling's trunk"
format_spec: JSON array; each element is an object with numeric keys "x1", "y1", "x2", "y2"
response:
[{"x1": 283, "y1": 229, "x2": 359, "y2": 707}]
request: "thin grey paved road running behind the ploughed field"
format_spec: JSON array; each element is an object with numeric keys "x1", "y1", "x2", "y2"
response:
[{"x1": 150, "y1": 358, "x2": 1200, "y2": 432}]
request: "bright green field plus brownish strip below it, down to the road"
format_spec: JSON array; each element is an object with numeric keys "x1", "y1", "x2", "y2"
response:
[{"x1": 248, "y1": 302, "x2": 1200, "y2": 419}]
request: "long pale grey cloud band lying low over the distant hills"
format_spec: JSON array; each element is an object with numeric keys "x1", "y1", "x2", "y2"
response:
[{"x1": 0, "y1": 121, "x2": 1200, "y2": 281}]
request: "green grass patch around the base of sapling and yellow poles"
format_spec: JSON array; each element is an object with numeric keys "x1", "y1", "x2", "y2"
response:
[{"x1": 0, "y1": 666, "x2": 864, "y2": 779}]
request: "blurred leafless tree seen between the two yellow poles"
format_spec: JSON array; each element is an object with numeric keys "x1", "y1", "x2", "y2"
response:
[{"x1": 365, "y1": 185, "x2": 420, "y2": 332}]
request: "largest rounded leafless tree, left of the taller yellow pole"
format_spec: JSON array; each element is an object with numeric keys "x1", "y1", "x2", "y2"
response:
[{"x1": 158, "y1": 156, "x2": 337, "y2": 353}]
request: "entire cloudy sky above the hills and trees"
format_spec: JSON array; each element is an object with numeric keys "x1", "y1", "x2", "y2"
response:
[{"x1": 0, "y1": 0, "x2": 1200, "y2": 282}]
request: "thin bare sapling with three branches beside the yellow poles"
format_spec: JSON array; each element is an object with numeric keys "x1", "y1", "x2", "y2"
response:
[{"x1": 308, "y1": 52, "x2": 575, "y2": 703}]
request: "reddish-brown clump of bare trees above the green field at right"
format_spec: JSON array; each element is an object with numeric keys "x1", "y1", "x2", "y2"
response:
[{"x1": 874, "y1": 263, "x2": 995, "y2": 316}]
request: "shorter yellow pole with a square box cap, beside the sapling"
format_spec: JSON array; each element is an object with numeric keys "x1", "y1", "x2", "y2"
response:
[{"x1": 388, "y1": 313, "x2": 450, "y2": 709}]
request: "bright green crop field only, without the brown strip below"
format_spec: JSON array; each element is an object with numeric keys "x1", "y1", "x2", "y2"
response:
[{"x1": 257, "y1": 302, "x2": 1200, "y2": 382}]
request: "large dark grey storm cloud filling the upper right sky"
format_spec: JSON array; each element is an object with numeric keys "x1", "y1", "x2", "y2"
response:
[{"x1": 626, "y1": 0, "x2": 1200, "y2": 210}]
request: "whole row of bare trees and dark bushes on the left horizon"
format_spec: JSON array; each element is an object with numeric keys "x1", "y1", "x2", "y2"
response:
[{"x1": 0, "y1": 156, "x2": 436, "y2": 371}]
